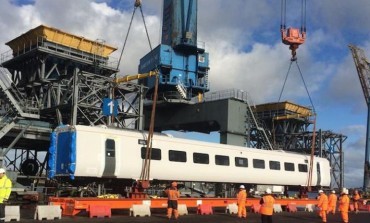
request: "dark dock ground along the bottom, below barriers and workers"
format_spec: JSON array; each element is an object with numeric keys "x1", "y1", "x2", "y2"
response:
[{"x1": 15, "y1": 209, "x2": 370, "y2": 223}]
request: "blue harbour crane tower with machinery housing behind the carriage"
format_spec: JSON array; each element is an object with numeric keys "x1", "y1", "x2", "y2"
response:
[{"x1": 139, "y1": 0, "x2": 209, "y2": 100}]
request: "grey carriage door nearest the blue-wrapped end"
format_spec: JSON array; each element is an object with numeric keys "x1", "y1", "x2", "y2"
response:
[{"x1": 103, "y1": 139, "x2": 116, "y2": 177}]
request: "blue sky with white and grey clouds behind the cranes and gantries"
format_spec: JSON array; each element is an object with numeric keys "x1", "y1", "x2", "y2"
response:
[{"x1": 0, "y1": 0, "x2": 370, "y2": 187}]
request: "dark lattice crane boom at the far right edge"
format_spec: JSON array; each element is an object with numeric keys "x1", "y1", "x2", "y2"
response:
[{"x1": 349, "y1": 45, "x2": 370, "y2": 191}]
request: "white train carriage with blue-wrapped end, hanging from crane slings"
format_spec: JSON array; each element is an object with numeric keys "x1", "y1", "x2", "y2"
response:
[{"x1": 49, "y1": 125, "x2": 330, "y2": 187}]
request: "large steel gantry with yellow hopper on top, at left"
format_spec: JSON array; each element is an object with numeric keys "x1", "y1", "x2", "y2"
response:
[{"x1": 0, "y1": 25, "x2": 145, "y2": 180}]
